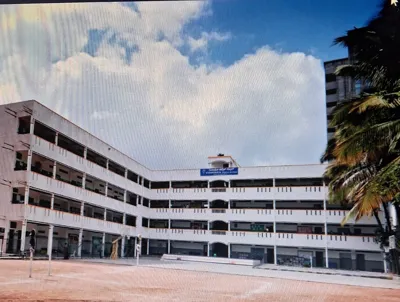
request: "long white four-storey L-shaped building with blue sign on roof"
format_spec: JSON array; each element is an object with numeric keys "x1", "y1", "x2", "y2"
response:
[{"x1": 0, "y1": 101, "x2": 384, "y2": 271}]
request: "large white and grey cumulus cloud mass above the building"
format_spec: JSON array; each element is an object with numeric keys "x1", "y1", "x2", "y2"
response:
[{"x1": 0, "y1": 1, "x2": 326, "y2": 169}]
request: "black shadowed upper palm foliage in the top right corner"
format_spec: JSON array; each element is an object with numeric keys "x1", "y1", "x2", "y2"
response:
[{"x1": 334, "y1": 0, "x2": 400, "y2": 91}]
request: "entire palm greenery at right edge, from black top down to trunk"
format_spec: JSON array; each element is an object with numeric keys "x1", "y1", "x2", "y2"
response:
[{"x1": 321, "y1": 1, "x2": 400, "y2": 273}]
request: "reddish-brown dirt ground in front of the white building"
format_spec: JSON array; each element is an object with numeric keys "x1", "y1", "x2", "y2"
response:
[{"x1": 0, "y1": 260, "x2": 400, "y2": 302}]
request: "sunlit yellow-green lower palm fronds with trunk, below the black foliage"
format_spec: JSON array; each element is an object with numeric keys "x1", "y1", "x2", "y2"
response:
[{"x1": 322, "y1": 93, "x2": 400, "y2": 273}]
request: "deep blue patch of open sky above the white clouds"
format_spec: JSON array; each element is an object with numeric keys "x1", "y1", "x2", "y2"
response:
[{"x1": 181, "y1": 0, "x2": 380, "y2": 64}]
